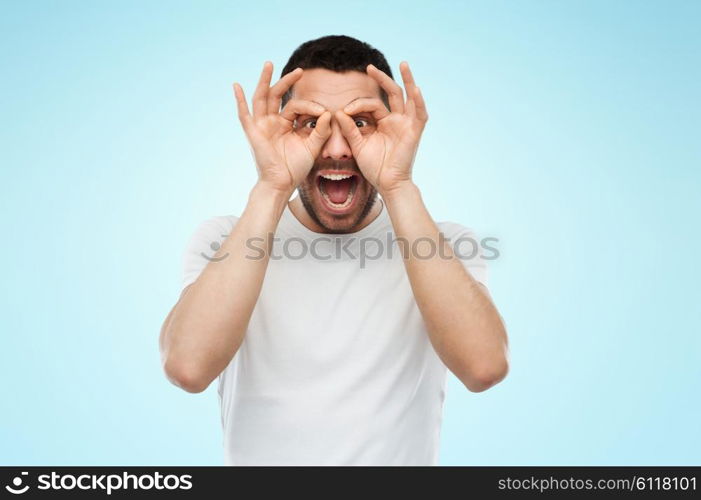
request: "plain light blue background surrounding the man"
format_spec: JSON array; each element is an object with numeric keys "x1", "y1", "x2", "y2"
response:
[{"x1": 0, "y1": 1, "x2": 701, "y2": 465}]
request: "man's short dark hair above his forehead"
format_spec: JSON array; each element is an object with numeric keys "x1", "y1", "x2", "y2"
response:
[{"x1": 280, "y1": 35, "x2": 394, "y2": 109}]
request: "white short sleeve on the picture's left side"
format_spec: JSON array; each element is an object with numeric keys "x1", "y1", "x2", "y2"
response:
[{"x1": 181, "y1": 215, "x2": 238, "y2": 291}]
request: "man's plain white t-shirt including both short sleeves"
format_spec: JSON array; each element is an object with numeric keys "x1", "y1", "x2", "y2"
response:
[{"x1": 183, "y1": 198, "x2": 487, "y2": 465}]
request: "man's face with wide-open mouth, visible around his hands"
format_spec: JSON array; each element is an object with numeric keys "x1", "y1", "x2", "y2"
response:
[{"x1": 292, "y1": 68, "x2": 380, "y2": 233}]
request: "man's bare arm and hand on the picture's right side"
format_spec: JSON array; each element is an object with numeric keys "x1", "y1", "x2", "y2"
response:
[{"x1": 336, "y1": 61, "x2": 508, "y2": 392}]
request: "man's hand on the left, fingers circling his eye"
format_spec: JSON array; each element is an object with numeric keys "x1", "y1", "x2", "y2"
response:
[{"x1": 234, "y1": 61, "x2": 331, "y2": 196}]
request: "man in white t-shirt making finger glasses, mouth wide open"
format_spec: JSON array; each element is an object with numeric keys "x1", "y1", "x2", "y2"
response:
[{"x1": 160, "y1": 36, "x2": 508, "y2": 465}]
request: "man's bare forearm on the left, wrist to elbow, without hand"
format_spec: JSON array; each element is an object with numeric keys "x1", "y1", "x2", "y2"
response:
[{"x1": 161, "y1": 183, "x2": 289, "y2": 392}]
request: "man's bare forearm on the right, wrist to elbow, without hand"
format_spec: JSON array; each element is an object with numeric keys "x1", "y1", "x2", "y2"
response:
[{"x1": 383, "y1": 183, "x2": 508, "y2": 391}]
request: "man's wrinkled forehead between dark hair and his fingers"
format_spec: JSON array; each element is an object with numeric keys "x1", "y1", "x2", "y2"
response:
[{"x1": 292, "y1": 68, "x2": 381, "y2": 111}]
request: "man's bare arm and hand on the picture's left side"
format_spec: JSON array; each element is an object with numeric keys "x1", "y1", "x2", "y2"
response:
[{"x1": 159, "y1": 61, "x2": 331, "y2": 392}]
